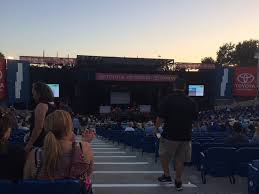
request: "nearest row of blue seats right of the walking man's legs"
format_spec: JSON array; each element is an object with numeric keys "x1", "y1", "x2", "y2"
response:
[{"x1": 200, "y1": 147, "x2": 259, "y2": 184}]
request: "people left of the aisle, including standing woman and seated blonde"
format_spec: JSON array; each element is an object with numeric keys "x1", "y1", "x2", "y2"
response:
[{"x1": 0, "y1": 82, "x2": 95, "y2": 192}]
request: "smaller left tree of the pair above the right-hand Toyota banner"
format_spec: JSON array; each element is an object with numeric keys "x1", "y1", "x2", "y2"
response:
[{"x1": 217, "y1": 43, "x2": 235, "y2": 66}]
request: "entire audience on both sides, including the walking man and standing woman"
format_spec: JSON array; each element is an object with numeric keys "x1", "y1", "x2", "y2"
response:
[{"x1": 0, "y1": 80, "x2": 259, "y2": 190}]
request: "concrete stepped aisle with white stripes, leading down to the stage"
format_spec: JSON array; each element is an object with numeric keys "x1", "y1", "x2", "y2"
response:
[{"x1": 92, "y1": 139, "x2": 198, "y2": 194}]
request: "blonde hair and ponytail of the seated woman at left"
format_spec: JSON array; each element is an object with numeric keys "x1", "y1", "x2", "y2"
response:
[{"x1": 43, "y1": 110, "x2": 73, "y2": 177}]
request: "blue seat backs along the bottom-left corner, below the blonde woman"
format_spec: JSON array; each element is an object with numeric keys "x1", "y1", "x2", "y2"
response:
[{"x1": 0, "y1": 180, "x2": 90, "y2": 194}]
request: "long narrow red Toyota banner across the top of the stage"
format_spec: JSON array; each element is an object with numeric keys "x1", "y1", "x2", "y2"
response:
[{"x1": 96, "y1": 73, "x2": 177, "y2": 82}]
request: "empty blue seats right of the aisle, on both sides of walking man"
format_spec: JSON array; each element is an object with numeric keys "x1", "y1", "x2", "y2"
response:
[{"x1": 96, "y1": 126, "x2": 259, "y2": 194}]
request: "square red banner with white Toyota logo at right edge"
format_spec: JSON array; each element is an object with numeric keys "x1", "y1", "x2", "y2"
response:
[{"x1": 233, "y1": 67, "x2": 257, "y2": 96}]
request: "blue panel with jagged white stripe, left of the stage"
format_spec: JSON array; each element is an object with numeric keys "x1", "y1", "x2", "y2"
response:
[{"x1": 7, "y1": 60, "x2": 31, "y2": 104}]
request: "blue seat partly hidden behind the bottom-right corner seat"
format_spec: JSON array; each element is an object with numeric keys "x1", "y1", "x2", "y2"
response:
[{"x1": 235, "y1": 147, "x2": 259, "y2": 177}]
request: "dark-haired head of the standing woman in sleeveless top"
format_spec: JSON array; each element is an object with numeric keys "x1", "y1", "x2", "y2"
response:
[{"x1": 32, "y1": 82, "x2": 54, "y2": 102}]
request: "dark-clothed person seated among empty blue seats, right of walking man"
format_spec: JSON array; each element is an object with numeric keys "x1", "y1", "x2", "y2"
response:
[{"x1": 225, "y1": 122, "x2": 249, "y2": 145}]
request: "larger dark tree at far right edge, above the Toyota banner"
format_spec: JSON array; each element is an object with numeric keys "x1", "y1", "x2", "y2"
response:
[{"x1": 235, "y1": 40, "x2": 259, "y2": 66}]
